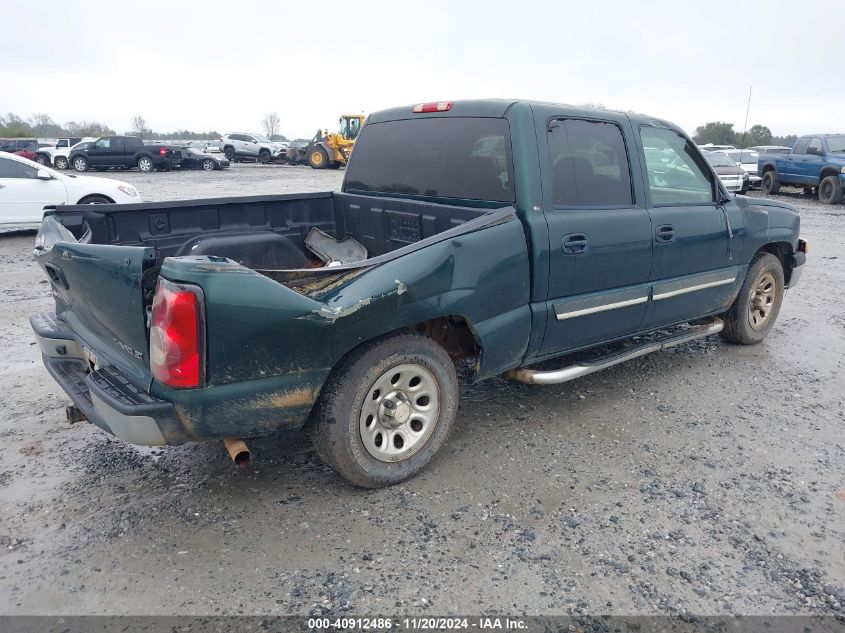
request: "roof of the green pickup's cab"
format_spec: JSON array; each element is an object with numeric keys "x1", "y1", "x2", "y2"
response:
[{"x1": 367, "y1": 99, "x2": 679, "y2": 129}]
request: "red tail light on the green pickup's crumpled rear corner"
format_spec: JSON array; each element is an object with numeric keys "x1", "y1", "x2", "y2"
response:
[{"x1": 150, "y1": 279, "x2": 205, "y2": 389}]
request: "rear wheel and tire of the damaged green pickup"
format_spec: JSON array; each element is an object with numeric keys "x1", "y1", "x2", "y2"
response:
[{"x1": 311, "y1": 334, "x2": 458, "y2": 488}]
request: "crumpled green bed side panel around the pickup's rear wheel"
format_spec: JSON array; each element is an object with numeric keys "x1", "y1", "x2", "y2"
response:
[{"x1": 153, "y1": 216, "x2": 530, "y2": 437}]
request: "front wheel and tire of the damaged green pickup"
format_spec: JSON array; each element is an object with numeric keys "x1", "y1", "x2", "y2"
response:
[{"x1": 721, "y1": 253, "x2": 784, "y2": 345}]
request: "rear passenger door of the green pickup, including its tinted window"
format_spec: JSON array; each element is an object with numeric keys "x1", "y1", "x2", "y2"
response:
[{"x1": 535, "y1": 108, "x2": 651, "y2": 356}]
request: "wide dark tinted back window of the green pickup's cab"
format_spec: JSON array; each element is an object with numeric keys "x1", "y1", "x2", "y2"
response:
[{"x1": 344, "y1": 117, "x2": 515, "y2": 202}]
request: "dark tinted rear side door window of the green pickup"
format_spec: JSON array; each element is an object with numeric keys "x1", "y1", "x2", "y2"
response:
[{"x1": 548, "y1": 119, "x2": 633, "y2": 207}]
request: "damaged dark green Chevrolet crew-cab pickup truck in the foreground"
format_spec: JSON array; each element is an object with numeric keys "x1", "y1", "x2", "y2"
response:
[{"x1": 31, "y1": 100, "x2": 806, "y2": 487}]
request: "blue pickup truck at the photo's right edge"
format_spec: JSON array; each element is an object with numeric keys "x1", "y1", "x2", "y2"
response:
[{"x1": 757, "y1": 134, "x2": 845, "y2": 204}]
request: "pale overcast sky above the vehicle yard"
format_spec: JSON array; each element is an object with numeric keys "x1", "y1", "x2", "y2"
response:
[{"x1": 0, "y1": 0, "x2": 845, "y2": 138}]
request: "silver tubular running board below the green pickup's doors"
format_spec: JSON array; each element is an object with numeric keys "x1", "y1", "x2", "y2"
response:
[{"x1": 505, "y1": 318, "x2": 725, "y2": 385}]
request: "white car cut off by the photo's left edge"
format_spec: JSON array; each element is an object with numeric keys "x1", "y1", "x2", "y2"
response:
[{"x1": 0, "y1": 153, "x2": 141, "y2": 225}]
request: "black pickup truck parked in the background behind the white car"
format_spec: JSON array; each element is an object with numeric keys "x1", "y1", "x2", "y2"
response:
[{"x1": 68, "y1": 136, "x2": 182, "y2": 171}]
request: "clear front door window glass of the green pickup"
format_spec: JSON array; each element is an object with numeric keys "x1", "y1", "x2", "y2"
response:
[{"x1": 640, "y1": 126, "x2": 716, "y2": 205}]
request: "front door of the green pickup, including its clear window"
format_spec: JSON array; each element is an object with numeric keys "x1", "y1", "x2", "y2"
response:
[{"x1": 639, "y1": 125, "x2": 744, "y2": 329}]
